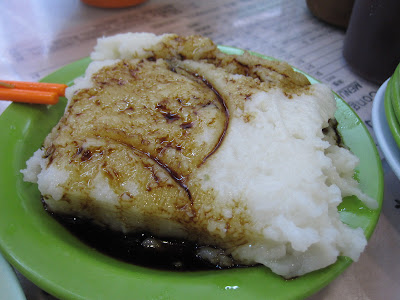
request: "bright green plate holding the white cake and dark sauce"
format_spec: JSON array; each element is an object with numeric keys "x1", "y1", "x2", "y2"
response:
[{"x1": 0, "y1": 47, "x2": 383, "y2": 300}]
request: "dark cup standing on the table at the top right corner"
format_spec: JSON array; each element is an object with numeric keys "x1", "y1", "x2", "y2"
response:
[{"x1": 343, "y1": 0, "x2": 400, "y2": 84}]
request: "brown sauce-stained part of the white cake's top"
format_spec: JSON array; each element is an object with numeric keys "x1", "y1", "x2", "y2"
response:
[{"x1": 45, "y1": 36, "x2": 309, "y2": 246}]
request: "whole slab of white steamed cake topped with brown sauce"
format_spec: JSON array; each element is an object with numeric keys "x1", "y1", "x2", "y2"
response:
[{"x1": 22, "y1": 33, "x2": 377, "y2": 278}]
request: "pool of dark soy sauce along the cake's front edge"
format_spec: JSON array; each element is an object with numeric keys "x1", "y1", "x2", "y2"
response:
[{"x1": 49, "y1": 212, "x2": 245, "y2": 271}]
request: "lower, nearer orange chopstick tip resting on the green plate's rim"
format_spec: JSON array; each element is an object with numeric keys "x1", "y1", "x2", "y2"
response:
[{"x1": 0, "y1": 87, "x2": 59, "y2": 104}]
